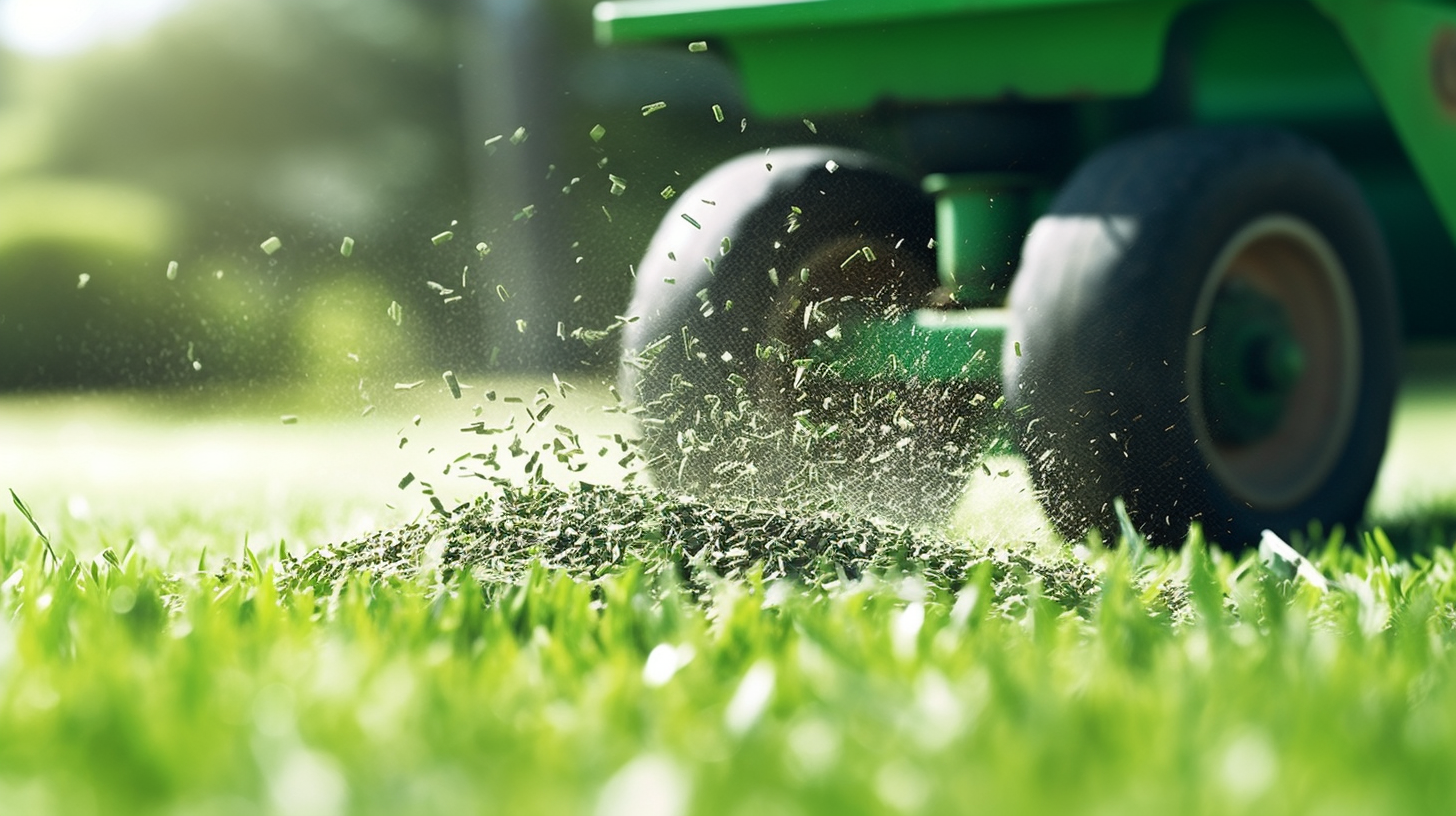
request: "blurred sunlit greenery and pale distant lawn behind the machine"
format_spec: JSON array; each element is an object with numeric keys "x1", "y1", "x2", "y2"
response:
[{"x1": 0, "y1": 0, "x2": 1456, "y2": 544}]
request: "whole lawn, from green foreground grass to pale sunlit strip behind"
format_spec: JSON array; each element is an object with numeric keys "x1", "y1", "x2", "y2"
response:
[{"x1": 0, "y1": 358, "x2": 1456, "y2": 816}]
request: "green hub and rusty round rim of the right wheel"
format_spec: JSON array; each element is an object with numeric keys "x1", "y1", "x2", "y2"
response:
[{"x1": 1187, "y1": 214, "x2": 1360, "y2": 510}]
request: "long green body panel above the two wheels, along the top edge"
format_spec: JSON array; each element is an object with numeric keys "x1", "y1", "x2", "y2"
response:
[{"x1": 596, "y1": 0, "x2": 1191, "y2": 117}]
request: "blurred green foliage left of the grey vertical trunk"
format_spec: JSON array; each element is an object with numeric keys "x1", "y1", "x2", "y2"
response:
[{"x1": 0, "y1": 0, "x2": 467, "y2": 389}]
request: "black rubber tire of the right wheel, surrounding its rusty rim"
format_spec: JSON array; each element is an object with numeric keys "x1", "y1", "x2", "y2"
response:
[{"x1": 1003, "y1": 128, "x2": 1399, "y2": 546}]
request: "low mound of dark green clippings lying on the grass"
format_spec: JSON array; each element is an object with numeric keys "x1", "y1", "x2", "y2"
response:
[{"x1": 294, "y1": 484, "x2": 1098, "y2": 609}]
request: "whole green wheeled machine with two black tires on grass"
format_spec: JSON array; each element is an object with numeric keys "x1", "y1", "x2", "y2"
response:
[{"x1": 596, "y1": 0, "x2": 1456, "y2": 546}]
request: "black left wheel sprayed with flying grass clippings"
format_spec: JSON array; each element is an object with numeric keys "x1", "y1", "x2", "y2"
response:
[{"x1": 620, "y1": 147, "x2": 978, "y2": 523}]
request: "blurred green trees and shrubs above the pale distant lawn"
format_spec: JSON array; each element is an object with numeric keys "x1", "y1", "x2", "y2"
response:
[{"x1": 0, "y1": 0, "x2": 844, "y2": 392}]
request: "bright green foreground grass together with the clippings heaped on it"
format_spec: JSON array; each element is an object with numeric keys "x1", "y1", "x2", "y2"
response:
[{"x1": 0, "y1": 488, "x2": 1456, "y2": 813}]
